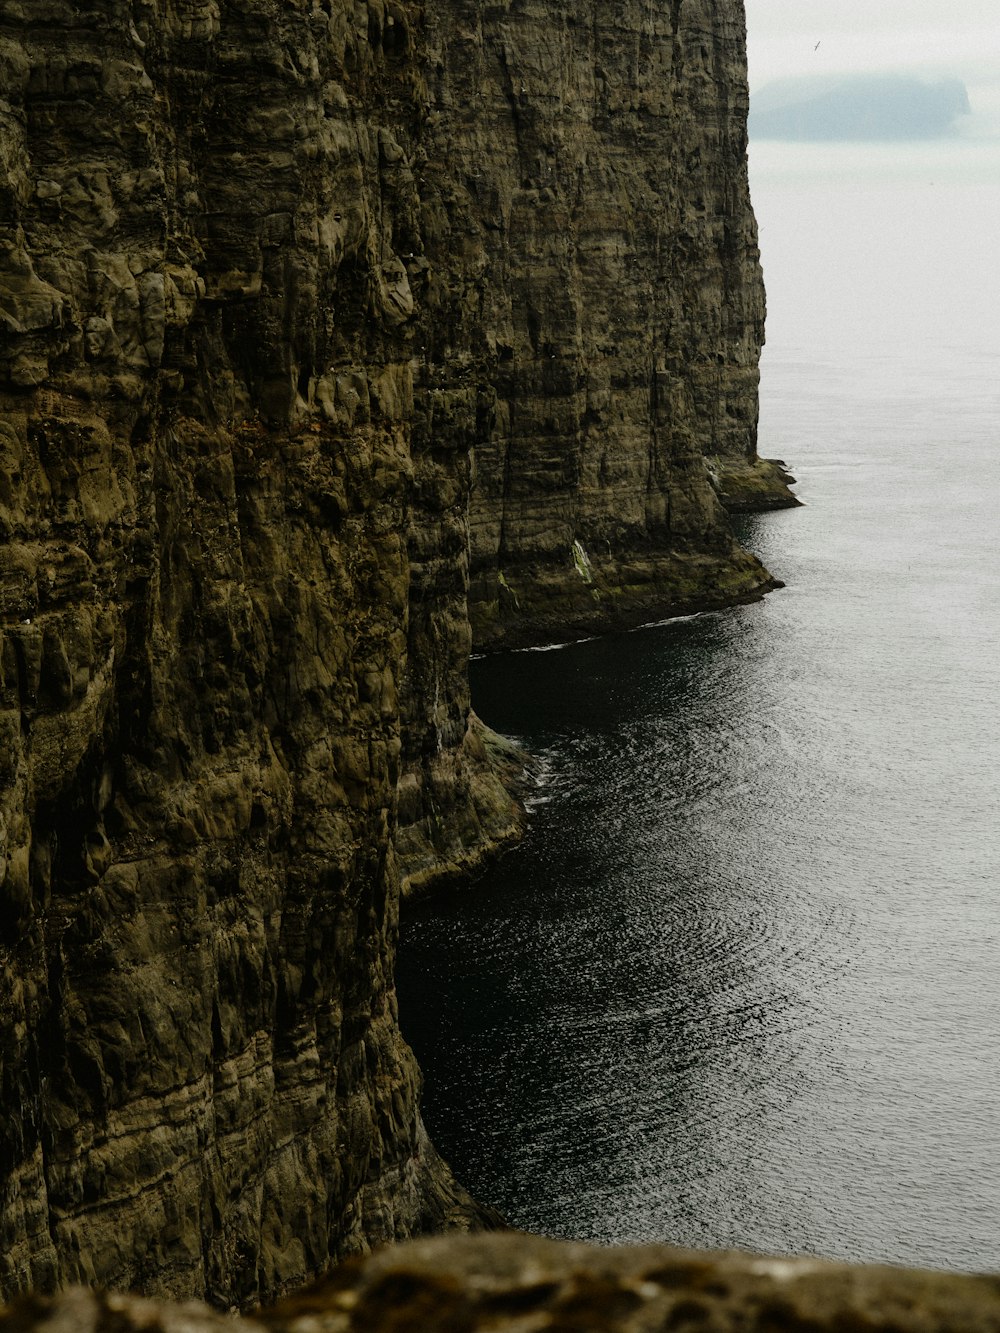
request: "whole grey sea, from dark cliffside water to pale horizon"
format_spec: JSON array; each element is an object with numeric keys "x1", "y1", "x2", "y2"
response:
[{"x1": 399, "y1": 137, "x2": 1000, "y2": 1272}]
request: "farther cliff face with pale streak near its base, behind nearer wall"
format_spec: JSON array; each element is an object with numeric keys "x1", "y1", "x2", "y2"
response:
[{"x1": 420, "y1": 0, "x2": 791, "y2": 645}]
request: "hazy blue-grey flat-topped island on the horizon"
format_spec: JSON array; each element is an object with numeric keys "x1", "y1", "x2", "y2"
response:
[{"x1": 749, "y1": 75, "x2": 971, "y2": 143}]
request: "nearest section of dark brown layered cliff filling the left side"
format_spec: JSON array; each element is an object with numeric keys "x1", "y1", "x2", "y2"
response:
[{"x1": 0, "y1": 0, "x2": 490, "y2": 1305}]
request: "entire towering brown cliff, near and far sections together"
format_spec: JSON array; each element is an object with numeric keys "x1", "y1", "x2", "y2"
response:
[{"x1": 0, "y1": 0, "x2": 794, "y2": 1305}]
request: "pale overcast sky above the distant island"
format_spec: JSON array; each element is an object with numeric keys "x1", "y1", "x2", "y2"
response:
[{"x1": 747, "y1": 0, "x2": 1000, "y2": 92}]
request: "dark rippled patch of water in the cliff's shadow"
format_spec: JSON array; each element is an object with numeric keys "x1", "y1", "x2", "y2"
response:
[{"x1": 401, "y1": 608, "x2": 857, "y2": 1248}]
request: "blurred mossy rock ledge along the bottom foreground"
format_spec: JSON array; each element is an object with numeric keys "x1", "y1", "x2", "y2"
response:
[{"x1": 0, "y1": 1234, "x2": 1000, "y2": 1333}]
